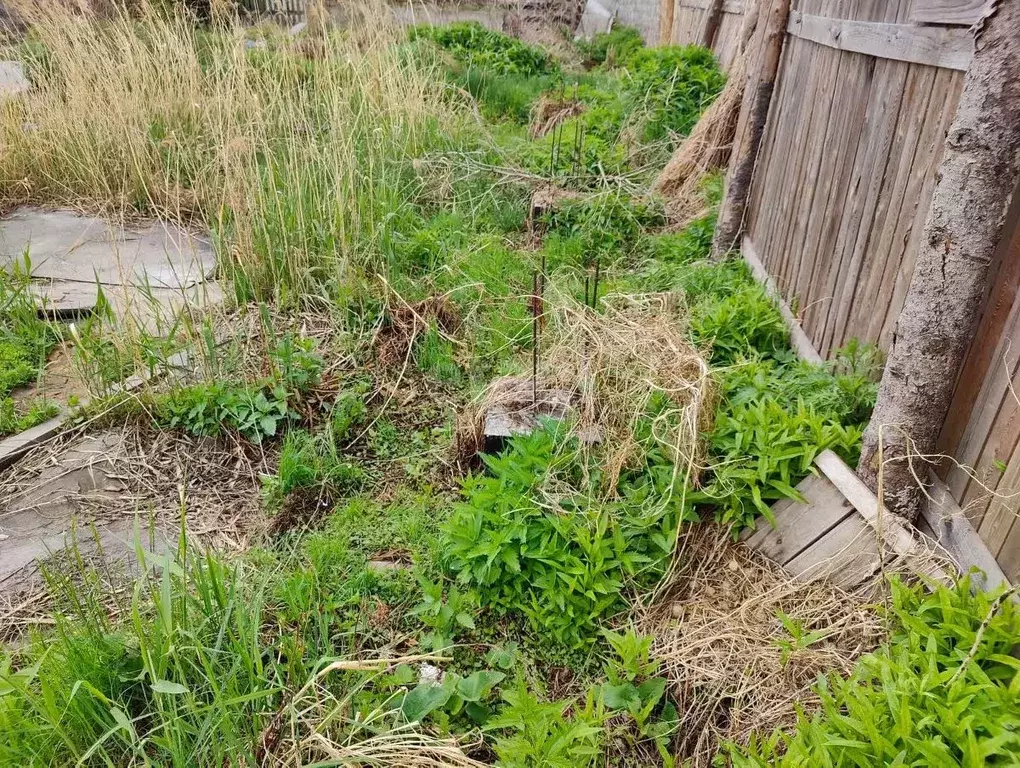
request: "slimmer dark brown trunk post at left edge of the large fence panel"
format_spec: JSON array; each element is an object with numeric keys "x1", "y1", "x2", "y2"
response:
[{"x1": 712, "y1": 0, "x2": 791, "y2": 259}]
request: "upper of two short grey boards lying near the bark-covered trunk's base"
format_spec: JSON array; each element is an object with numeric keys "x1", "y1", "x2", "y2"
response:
[{"x1": 747, "y1": 474, "x2": 857, "y2": 565}]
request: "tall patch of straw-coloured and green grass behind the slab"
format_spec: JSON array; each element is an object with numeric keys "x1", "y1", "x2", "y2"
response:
[{"x1": 0, "y1": 3, "x2": 467, "y2": 300}]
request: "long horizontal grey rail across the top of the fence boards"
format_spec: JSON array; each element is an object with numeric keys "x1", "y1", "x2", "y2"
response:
[{"x1": 786, "y1": 11, "x2": 974, "y2": 71}]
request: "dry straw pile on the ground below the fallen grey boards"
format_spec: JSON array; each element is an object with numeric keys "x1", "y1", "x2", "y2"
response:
[{"x1": 635, "y1": 525, "x2": 884, "y2": 768}]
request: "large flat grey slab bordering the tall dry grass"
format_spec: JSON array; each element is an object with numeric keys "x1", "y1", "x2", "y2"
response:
[{"x1": 0, "y1": 207, "x2": 216, "y2": 289}]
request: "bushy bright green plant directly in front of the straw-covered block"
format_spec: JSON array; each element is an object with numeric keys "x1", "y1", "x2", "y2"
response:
[{"x1": 446, "y1": 428, "x2": 680, "y2": 648}]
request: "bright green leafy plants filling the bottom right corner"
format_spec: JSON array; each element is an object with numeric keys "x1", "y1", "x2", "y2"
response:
[{"x1": 731, "y1": 578, "x2": 1020, "y2": 768}]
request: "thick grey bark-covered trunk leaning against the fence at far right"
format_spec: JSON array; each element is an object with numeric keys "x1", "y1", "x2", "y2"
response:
[{"x1": 858, "y1": 0, "x2": 1020, "y2": 521}]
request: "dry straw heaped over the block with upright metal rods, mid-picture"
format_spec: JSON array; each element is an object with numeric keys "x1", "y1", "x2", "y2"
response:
[{"x1": 473, "y1": 292, "x2": 712, "y2": 488}]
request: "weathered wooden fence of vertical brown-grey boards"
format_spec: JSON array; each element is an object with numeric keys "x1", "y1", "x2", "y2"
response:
[{"x1": 660, "y1": 0, "x2": 1020, "y2": 581}]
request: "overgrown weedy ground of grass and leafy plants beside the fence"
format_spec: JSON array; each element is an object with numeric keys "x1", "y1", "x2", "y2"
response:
[{"x1": 0, "y1": 9, "x2": 1018, "y2": 768}]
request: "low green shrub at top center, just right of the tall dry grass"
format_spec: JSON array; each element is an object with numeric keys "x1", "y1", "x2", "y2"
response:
[{"x1": 408, "y1": 21, "x2": 557, "y2": 75}]
